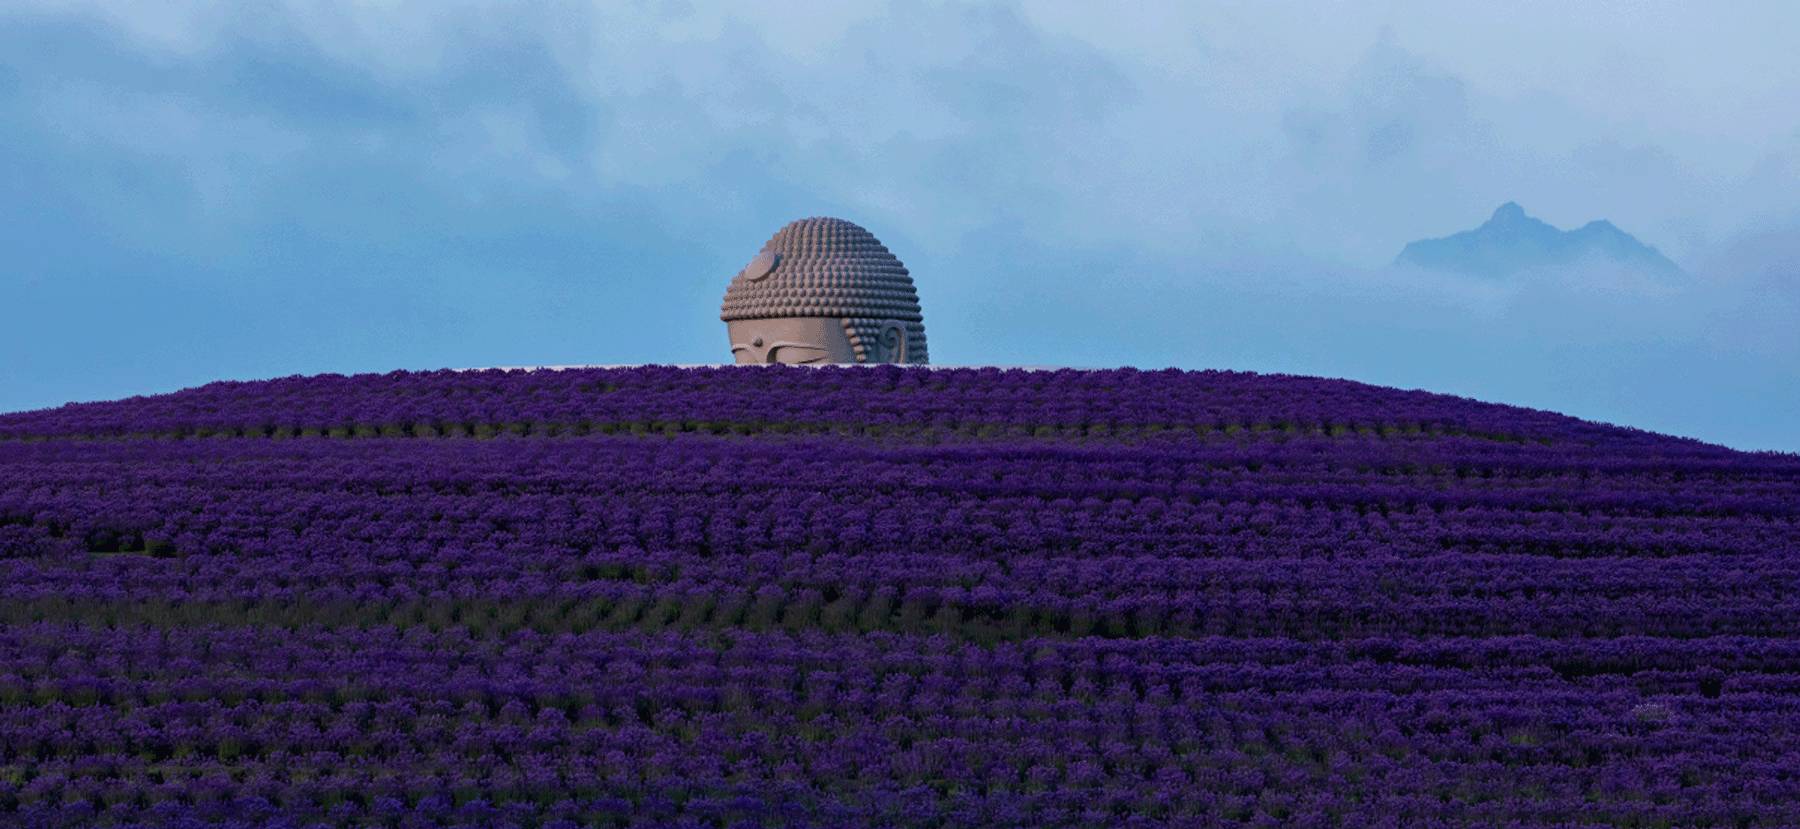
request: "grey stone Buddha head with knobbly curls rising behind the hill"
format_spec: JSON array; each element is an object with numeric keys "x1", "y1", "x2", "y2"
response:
[{"x1": 718, "y1": 218, "x2": 925, "y2": 365}]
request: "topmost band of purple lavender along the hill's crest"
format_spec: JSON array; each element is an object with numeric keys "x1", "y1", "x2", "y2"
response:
[{"x1": 0, "y1": 365, "x2": 1706, "y2": 449}]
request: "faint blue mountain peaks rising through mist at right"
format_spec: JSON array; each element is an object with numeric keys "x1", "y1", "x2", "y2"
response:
[{"x1": 1393, "y1": 201, "x2": 1683, "y2": 279}]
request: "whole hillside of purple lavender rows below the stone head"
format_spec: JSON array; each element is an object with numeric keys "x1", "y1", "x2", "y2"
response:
[{"x1": 0, "y1": 367, "x2": 1800, "y2": 827}]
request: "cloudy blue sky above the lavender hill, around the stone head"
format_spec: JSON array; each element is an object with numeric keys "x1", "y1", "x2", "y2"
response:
[{"x1": 0, "y1": 2, "x2": 1800, "y2": 451}]
